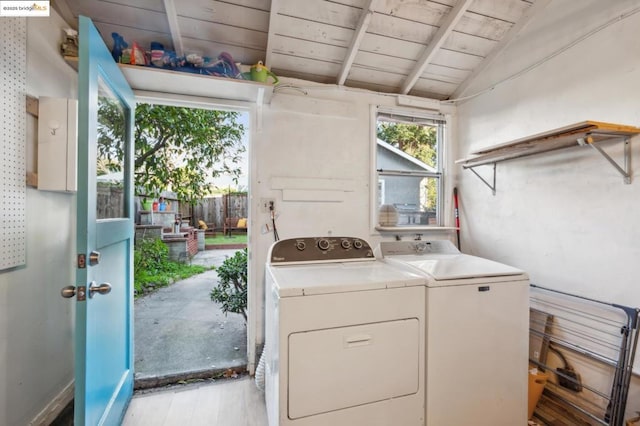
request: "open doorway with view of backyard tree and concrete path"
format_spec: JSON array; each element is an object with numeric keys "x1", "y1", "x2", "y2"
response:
[{"x1": 125, "y1": 100, "x2": 250, "y2": 389}]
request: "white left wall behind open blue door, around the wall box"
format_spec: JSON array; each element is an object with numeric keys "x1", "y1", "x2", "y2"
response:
[{"x1": 0, "y1": 13, "x2": 77, "y2": 426}]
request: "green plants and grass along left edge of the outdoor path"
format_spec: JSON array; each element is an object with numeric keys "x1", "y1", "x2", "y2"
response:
[{"x1": 133, "y1": 239, "x2": 206, "y2": 296}]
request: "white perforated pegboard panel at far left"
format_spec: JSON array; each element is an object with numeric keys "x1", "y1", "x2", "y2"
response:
[{"x1": 0, "y1": 17, "x2": 27, "y2": 269}]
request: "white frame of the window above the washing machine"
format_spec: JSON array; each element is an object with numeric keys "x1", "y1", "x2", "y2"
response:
[{"x1": 369, "y1": 105, "x2": 448, "y2": 233}]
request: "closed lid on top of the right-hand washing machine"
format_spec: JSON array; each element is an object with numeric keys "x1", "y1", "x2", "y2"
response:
[{"x1": 386, "y1": 254, "x2": 524, "y2": 281}]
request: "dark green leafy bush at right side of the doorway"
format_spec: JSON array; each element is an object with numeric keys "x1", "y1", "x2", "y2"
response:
[{"x1": 209, "y1": 249, "x2": 247, "y2": 321}]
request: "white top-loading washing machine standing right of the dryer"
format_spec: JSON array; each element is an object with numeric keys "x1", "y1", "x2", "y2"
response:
[{"x1": 379, "y1": 240, "x2": 529, "y2": 426}]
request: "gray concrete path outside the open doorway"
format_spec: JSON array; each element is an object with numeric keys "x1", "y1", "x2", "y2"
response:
[{"x1": 134, "y1": 249, "x2": 247, "y2": 388}]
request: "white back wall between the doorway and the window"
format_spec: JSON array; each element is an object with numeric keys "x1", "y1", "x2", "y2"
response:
[{"x1": 249, "y1": 85, "x2": 452, "y2": 362}]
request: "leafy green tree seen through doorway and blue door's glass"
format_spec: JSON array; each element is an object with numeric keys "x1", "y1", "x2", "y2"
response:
[{"x1": 98, "y1": 102, "x2": 245, "y2": 203}]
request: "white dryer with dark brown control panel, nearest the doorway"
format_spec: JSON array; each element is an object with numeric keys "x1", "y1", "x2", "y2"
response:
[{"x1": 265, "y1": 237, "x2": 425, "y2": 426}]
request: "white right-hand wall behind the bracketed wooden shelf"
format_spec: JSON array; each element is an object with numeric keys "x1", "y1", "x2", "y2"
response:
[{"x1": 457, "y1": 0, "x2": 640, "y2": 420}]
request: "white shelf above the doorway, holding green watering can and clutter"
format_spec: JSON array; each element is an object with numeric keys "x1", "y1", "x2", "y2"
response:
[{"x1": 65, "y1": 56, "x2": 274, "y2": 105}]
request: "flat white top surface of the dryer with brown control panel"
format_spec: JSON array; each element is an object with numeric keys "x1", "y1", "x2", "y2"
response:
[{"x1": 267, "y1": 261, "x2": 427, "y2": 297}]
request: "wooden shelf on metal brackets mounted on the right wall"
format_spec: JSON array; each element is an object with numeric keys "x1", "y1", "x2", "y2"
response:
[{"x1": 456, "y1": 121, "x2": 640, "y2": 195}]
